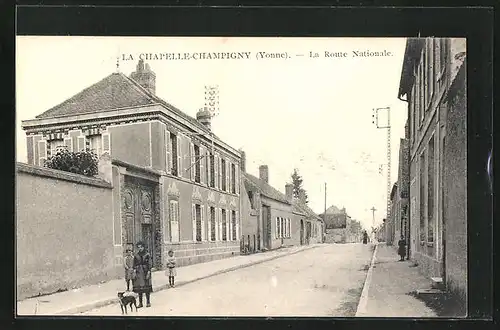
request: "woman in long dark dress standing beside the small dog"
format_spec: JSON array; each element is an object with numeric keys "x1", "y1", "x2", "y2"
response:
[{"x1": 132, "y1": 242, "x2": 153, "y2": 308}]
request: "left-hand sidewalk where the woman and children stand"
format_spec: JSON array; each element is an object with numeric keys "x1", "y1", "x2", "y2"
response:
[{"x1": 16, "y1": 244, "x2": 322, "y2": 315}]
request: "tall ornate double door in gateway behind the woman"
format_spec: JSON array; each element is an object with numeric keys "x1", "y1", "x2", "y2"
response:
[{"x1": 122, "y1": 177, "x2": 160, "y2": 267}]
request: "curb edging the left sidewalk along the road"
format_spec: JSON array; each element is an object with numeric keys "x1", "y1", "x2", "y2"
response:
[{"x1": 54, "y1": 245, "x2": 319, "y2": 315}]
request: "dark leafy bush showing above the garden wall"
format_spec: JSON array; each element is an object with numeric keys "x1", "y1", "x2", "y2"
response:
[{"x1": 44, "y1": 149, "x2": 99, "y2": 176}]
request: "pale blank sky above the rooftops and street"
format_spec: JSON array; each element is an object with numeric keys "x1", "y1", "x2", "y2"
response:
[{"x1": 16, "y1": 36, "x2": 407, "y2": 228}]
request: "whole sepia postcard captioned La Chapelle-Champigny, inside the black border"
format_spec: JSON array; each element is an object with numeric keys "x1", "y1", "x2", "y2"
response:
[{"x1": 16, "y1": 36, "x2": 468, "y2": 317}]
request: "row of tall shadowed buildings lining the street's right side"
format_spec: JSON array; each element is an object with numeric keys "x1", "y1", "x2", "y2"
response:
[{"x1": 385, "y1": 38, "x2": 467, "y2": 306}]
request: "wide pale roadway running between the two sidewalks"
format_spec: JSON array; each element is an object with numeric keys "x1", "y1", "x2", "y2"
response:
[{"x1": 79, "y1": 244, "x2": 373, "y2": 317}]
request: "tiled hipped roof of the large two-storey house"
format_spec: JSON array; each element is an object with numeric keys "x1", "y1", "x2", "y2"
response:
[{"x1": 36, "y1": 73, "x2": 157, "y2": 119}]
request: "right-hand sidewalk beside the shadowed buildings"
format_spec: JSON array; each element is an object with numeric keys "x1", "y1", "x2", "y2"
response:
[{"x1": 356, "y1": 243, "x2": 437, "y2": 317}]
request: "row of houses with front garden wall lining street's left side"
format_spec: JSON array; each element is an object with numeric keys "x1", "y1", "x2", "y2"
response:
[{"x1": 16, "y1": 60, "x2": 323, "y2": 299}]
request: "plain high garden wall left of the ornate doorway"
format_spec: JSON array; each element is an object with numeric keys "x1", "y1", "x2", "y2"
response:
[{"x1": 16, "y1": 163, "x2": 116, "y2": 300}]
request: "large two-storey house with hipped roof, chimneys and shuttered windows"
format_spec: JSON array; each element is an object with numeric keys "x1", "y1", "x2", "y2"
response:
[{"x1": 23, "y1": 60, "x2": 241, "y2": 269}]
